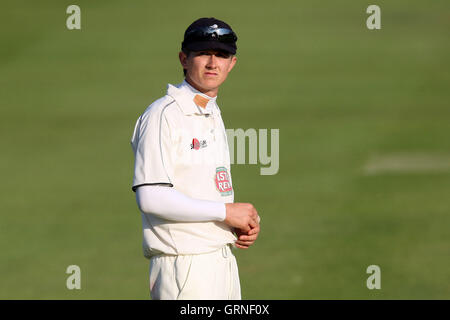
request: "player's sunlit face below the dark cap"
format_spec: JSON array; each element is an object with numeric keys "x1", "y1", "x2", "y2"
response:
[{"x1": 179, "y1": 50, "x2": 236, "y2": 95}]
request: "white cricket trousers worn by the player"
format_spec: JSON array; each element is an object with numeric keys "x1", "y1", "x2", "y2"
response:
[{"x1": 150, "y1": 245, "x2": 241, "y2": 300}]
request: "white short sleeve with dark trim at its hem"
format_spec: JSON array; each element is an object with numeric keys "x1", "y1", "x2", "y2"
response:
[{"x1": 131, "y1": 105, "x2": 173, "y2": 192}]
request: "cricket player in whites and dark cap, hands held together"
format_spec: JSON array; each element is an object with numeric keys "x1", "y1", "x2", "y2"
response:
[{"x1": 131, "y1": 18, "x2": 260, "y2": 300}]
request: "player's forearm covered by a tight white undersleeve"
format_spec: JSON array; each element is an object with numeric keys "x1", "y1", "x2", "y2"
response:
[{"x1": 136, "y1": 185, "x2": 226, "y2": 222}]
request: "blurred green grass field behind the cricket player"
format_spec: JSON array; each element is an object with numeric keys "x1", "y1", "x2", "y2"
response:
[{"x1": 0, "y1": 0, "x2": 450, "y2": 299}]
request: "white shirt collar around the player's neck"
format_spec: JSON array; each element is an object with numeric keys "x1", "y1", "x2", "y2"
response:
[{"x1": 167, "y1": 80, "x2": 220, "y2": 115}]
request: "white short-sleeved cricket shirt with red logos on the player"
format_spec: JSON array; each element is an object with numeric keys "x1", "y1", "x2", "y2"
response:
[{"x1": 131, "y1": 81, "x2": 236, "y2": 258}]
